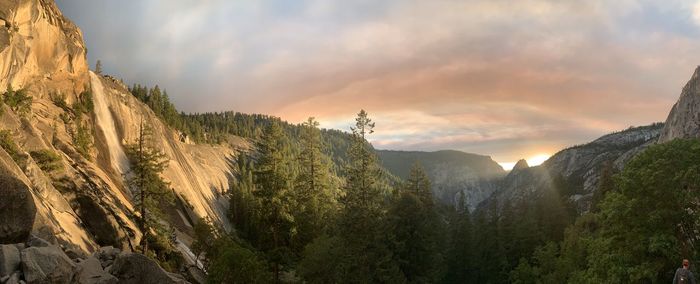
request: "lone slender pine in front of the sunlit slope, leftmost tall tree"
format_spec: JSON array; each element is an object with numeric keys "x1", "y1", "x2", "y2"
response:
[{"x1": 126, "y1": 121, "x2": 173, "y2": 254}]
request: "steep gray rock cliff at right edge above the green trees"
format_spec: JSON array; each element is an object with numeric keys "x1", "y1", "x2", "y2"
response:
[{"x1": 659, "y1": 66, "x2": 700, "y2": 143}]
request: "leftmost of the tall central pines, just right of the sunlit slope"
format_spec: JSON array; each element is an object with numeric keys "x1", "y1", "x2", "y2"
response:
[{"x1": 254, "y1": 122, "x2": 296, "y2": 282}]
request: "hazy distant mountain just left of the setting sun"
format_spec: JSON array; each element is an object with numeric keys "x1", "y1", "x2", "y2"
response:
[{"x1": 377, "y1": 150, "x2": 506, "y2": 209}]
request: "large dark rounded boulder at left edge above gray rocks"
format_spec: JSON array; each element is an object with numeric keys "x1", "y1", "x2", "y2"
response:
[{"x1": 0, "y1": 174, "x2": 36, "y2": 244}]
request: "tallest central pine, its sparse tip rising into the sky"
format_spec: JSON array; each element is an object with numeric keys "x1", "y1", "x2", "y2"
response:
[{"x1": 338, "y1": 110, "x2": 403, "y2": 283}]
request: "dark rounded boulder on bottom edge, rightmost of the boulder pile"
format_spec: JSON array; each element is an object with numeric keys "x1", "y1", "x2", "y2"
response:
[{"x1": 109, "y1": 253, "x2": 189, "y2": 284}]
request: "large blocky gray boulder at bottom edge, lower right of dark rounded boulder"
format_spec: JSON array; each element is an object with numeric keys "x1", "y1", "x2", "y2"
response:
[{"x1": 21, "y1": 246, "x2": 76, "y2": 283}]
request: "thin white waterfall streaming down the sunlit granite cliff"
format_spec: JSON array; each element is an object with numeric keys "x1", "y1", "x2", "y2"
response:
[{"x1": 90, "y1": 71, "x2": 129, "y2": 174}]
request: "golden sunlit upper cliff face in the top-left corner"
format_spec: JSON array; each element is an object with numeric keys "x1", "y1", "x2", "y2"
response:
[{"x1": 0, "y1": 0, "x2": 88, "y2": 93}]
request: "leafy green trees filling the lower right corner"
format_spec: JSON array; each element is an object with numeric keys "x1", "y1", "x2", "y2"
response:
[{"x1": 511, "y1": 140, "x2": 700, "y2": 283}]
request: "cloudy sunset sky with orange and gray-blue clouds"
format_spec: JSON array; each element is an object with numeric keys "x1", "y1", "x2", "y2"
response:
[{"x1": 57, "y1": 0, "x2": 700, "y2": 168}]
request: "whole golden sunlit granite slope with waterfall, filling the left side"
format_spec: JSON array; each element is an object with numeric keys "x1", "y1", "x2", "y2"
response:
[{"x1": 0, "y1": 0, "x2": 248, "y2": 278}]
